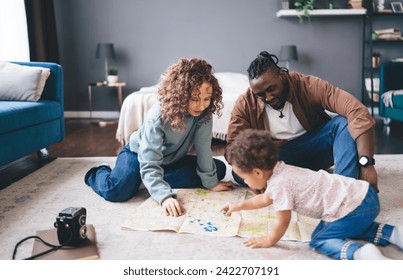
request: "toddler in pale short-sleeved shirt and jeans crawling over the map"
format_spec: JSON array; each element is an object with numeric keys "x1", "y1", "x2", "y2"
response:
[{"x1": 222, "y1": 129, "x2": 403, "y2": 259}]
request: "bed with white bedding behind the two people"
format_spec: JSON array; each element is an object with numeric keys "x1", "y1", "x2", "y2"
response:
[{"x1": 116, "y1": 72, "x2": 249, "y2": 145}]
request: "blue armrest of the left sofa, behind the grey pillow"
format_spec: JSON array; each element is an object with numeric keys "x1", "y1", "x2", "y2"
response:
[{"x1": 12, "y1": 61, "x2": 64, "y2": 103}]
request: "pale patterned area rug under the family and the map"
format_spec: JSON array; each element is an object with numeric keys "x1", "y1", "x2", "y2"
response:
[{"x1": 0, "y1": 155, "x2": 403, "y2": 260}]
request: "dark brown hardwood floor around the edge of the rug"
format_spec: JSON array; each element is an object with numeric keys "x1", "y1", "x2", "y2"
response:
[{"x1": 0, "y1": 118, "x2": 403, "y2": 189}]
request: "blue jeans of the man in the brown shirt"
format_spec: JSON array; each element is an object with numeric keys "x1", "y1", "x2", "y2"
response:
[{"x1": 232, "y1": 116, "x2": 359, "y2": 185}]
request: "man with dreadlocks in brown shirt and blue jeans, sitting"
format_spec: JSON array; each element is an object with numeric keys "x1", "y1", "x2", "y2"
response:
[{"x1": 227, "y1": 51, "x2": 379, "y2": 192}]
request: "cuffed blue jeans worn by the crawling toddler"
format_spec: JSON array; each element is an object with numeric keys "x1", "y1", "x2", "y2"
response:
[{"x1": 309, "y1": 186, "x2": 394, "y2": 260}]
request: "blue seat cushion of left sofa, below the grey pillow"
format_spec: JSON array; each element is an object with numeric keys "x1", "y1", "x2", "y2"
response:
[{"x1": 0, "y1": 100, "x2": 63, "y2": 135}]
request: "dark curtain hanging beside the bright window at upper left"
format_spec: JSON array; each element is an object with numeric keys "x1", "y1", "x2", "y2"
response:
[{"x1": 25, "y1": 0, "x2": 59, "y2": 63}]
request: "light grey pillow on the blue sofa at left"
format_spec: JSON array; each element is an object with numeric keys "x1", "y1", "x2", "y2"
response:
[{"x1": 0, "y1": 61, "x2": 50, "y2": 101}]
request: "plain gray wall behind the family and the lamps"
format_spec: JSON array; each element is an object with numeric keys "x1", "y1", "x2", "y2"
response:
[{"x1": 55, "y1": 0, "x2": 370, "y2": 114}]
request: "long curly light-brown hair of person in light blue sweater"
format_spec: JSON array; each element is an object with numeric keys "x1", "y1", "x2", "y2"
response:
[{"x1": 158, "y1": 58, "x2": 224, "y2": 131}]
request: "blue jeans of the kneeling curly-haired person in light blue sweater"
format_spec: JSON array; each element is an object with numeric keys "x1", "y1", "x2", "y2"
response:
[{"x1": 84, "y1": 144, "x2": 226, "y2": 201}]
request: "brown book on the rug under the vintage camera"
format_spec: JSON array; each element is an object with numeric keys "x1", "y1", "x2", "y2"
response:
[{"x1": 32, "y1": 224, "x2": 99, "y2": 260}]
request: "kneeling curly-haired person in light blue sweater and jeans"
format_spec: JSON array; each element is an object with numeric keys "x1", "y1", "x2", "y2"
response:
[{"x1": 84, "y1": 58, "x2": 237, "y2": 216}]
